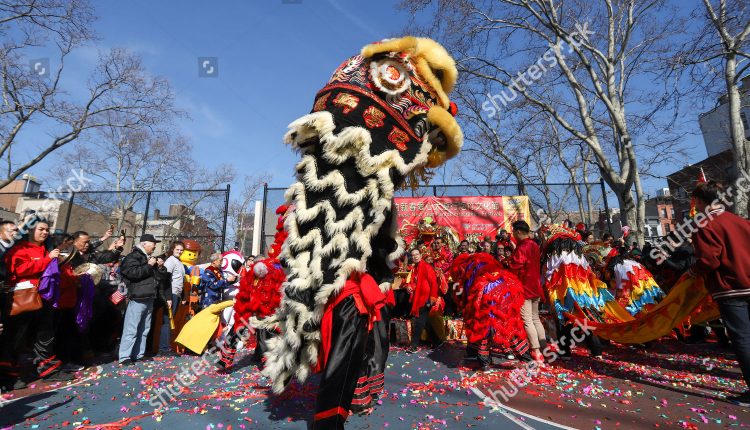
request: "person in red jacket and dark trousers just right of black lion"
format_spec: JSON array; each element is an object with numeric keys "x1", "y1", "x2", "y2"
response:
[{"x1": 406, "y1": 249, "x2": 440, "y2": 353}]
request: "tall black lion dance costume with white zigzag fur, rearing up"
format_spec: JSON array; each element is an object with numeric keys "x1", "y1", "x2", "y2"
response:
[{"x1": 264, "y1": 37, "x2": 463, "y2": 428}]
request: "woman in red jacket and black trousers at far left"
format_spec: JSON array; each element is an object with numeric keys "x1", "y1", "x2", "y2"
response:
[{"x1": 5, "y1": 218, "x2": 73, "y2": 381}]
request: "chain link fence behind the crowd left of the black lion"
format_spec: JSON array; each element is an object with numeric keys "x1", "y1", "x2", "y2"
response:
[{"x1": 0, "y1": 185, "x2": 230, "y2": 255}]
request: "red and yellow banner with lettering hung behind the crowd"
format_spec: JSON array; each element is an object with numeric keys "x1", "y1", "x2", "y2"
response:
[{"x1": 395, "y1": 196, "x2": 531, "y2": 244}]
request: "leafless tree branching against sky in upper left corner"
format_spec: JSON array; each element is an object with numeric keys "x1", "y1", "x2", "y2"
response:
[{"x1": 0, "y1": 0, "x2": 178, "y2": 188}]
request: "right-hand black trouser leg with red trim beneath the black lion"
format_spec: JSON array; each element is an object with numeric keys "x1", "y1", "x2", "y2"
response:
[{"x1": 351, "y1": 306, "x2": 391, "y2": 412}]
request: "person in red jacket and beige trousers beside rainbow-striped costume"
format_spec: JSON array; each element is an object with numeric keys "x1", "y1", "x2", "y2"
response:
[{"x1": 507, "y1": 221, "x2": 547, "y2": 362}]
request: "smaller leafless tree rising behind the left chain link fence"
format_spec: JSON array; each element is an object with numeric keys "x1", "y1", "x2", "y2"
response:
[{"x1": 53, "y1": 127, "x2": 234, "y2": 245}]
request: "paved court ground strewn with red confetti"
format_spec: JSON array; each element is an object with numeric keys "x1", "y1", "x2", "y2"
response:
[{"x1": 0, "y1": 341, "x2": 750, "y2": 430}]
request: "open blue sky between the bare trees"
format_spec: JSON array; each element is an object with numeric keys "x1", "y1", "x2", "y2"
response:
[{"x1": 25, "y1": 0, "x2": 706, "y2": 199}]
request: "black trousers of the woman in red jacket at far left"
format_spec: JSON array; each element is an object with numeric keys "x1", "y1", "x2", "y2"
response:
[{"x1": 4, "y1": 303, "x2": 62, "y2": 377}]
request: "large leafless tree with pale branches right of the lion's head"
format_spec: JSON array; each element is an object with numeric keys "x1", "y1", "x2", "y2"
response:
[{"x1": 402, "y1": 0, "x2": 692, "y2": 242}]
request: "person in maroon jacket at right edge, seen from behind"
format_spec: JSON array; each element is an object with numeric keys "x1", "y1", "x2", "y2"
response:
[{"x1": 691, "y1": 181, "x2": 750, "y2": 407}]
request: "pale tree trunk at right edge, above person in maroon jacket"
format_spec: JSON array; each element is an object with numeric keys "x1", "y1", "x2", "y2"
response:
[{"x1": 724, "y1": 54, "x2": 750, "y2": 218}]
